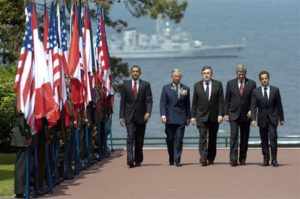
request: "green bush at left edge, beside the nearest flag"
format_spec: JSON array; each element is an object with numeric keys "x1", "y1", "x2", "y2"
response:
[{"x1": 0, "y1": 66, "x2": 16, "y2": 153}]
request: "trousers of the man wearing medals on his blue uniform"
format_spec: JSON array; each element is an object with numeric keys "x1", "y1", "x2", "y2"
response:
[{"x1": 165, "y1": 124, "x2": 185, "y2": 163}]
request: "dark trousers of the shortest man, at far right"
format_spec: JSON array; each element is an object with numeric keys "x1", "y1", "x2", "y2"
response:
[{"x1": 259, "y1": 122, "x2": 278, "y2": 161}]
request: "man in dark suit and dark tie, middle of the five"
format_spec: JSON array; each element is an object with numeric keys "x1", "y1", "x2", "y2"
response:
[{"x1": 191, "y1": 66, "x2": 224, "y2": 166}]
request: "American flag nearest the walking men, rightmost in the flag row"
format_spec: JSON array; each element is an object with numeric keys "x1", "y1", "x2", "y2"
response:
[{"x1": 96, "y1": 7, "x2": 114, "y2": 96}]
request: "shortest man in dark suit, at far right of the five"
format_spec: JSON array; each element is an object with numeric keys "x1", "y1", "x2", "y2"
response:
[{"x1": 251, "y1": 71, "x2": 284, "y2": 167}]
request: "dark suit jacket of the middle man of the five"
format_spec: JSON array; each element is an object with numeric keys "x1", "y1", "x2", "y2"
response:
[{"x1": 192, "y1": 79, "x2": 224, "y2": 124}]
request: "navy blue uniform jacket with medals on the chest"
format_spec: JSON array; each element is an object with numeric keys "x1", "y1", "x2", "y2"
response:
[{"x1": 160, "y1": 83, "x2": 191, "y2": 124}]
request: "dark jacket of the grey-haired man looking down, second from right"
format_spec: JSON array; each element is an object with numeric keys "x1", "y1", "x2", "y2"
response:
[{"x1": 224, "y1": 78, "x2": 256, "y2": 121}]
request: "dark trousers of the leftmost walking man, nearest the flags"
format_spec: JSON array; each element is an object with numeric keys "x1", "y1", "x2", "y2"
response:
[{"x1": 126, "y1": 121, "x2": 146, "y2": 163}]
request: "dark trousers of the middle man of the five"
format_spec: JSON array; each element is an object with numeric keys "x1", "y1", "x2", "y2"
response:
[{"x1": 197, "y1": 121, "x2": 219, "y2": 161}]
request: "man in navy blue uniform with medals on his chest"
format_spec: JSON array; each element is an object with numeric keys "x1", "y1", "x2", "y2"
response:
[{"x1": 160, "y1": 68, "x2": 191, "y2": 167}]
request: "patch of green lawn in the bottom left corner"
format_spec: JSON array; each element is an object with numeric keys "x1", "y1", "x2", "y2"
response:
[{"x1": 0, "y1": 153, "x2": 16, "y2": 197}]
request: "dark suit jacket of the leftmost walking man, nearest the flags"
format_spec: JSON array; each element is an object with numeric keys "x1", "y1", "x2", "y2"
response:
[{"x1": 119, "y1": 79, "x2": 153, "y2": 124}]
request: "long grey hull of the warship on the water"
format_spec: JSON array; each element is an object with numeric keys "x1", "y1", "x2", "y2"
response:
[{"x1": 110, "y1": 45, "x2": 245, "y2": 59}]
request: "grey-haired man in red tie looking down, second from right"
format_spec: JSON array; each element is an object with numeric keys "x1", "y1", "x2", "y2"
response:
[{"x1": 224, "y1": 64, "x2": 256, "y2": 166}]
